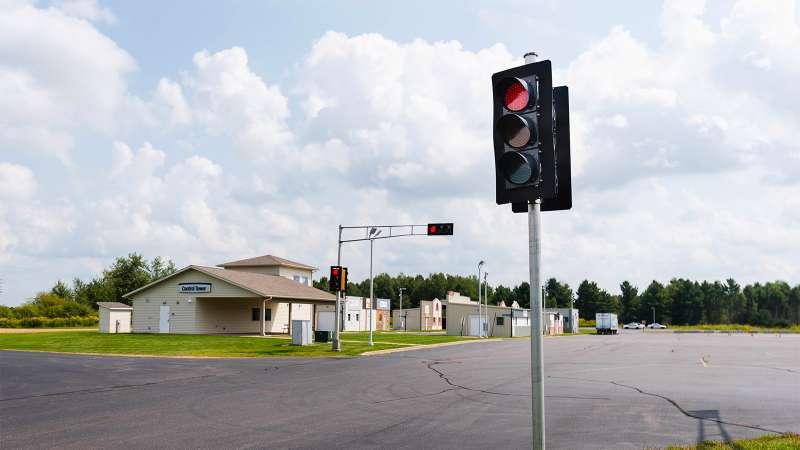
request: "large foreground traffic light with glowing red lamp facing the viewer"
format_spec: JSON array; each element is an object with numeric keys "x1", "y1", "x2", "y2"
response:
[{"x1": 492, "y1": 60, "x2": 557, "y2": 205}]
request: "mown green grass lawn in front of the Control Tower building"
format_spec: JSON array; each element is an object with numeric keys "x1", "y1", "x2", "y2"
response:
[{"x1": 0, "y1": 331, "x2": 476, "y2": 357}]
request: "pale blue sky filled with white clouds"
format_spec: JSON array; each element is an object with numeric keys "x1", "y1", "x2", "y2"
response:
[{"x1": 0, "y1": 0, "x2": 800, "y2": 305}]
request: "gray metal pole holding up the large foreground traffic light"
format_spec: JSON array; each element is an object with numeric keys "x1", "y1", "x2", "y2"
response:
[{"x1": 525, "y1": 52, "x2": 545, "y2": 450}]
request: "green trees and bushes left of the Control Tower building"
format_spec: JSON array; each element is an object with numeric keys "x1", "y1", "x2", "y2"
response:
[{"x1": 0, "y1": 253, "x2": 176, "y2": 320}]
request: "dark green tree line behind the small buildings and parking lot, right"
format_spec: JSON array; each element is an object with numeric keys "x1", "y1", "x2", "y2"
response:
[{"x1": 314, "y1": 273, "x2": 800, "y2": 327}]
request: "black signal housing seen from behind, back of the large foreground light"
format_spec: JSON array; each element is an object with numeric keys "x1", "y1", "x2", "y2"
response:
[{"x1": 511, "y1": 86, "x2": 572, "y2": 213}]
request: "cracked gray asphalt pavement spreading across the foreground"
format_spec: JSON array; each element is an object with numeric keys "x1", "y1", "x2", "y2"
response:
[{"x1": 0, "y1": 330, "x2": 800, "y2": 449}]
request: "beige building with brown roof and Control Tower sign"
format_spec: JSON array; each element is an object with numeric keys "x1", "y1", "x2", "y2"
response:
[{"x1": 124, "y1": 255, "x2": 336, "y2": 334}]
